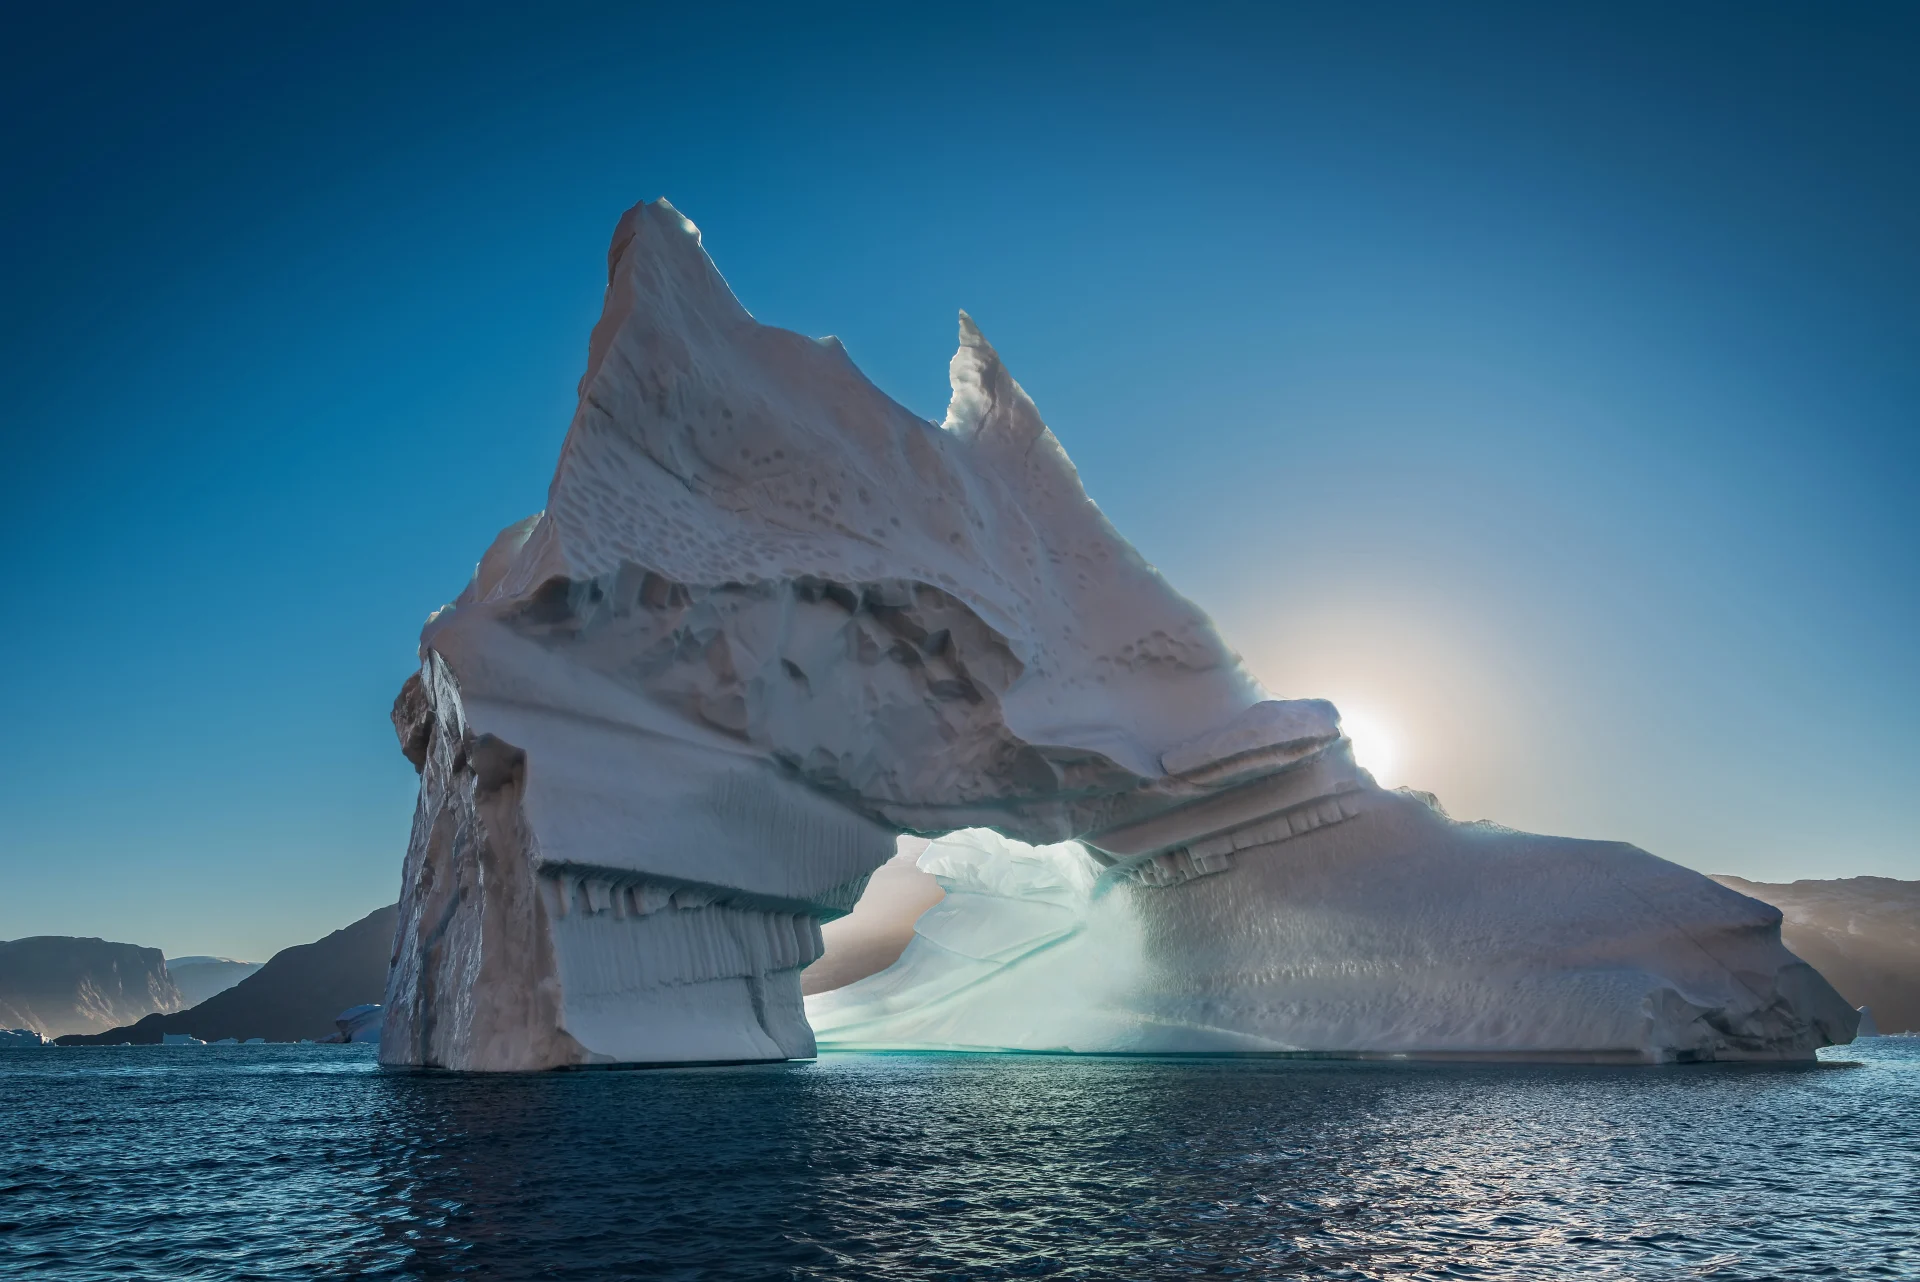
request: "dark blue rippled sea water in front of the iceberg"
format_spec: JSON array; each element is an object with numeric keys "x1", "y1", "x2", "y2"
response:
[{"x1": 0, "y1": 1038, "x2": 1920, "y2": 1282}]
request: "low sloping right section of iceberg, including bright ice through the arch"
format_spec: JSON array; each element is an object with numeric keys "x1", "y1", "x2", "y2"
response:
[{"x1": 806, "y1": 787, "x2": 1855, "y2": 1063}]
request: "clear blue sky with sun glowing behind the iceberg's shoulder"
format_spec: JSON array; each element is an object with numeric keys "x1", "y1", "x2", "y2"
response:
[{"x1": 0, "y1": 4, "x2": 1920, "y2": 960}]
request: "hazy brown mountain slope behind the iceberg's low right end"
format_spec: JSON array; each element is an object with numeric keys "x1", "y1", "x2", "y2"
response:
[{"x1": 1715, "y1": 877, "x2": 1920, "y2": 1033}]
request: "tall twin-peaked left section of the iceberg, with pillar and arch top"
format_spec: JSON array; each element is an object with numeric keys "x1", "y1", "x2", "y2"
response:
[{"x1": 382, "y1": 202, "x2": 1858, "y2": 1069}]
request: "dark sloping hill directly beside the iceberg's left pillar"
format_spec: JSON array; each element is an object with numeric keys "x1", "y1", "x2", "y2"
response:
[{"x1": 59, "y1": 904, "x2": 399, "y2": 1046}]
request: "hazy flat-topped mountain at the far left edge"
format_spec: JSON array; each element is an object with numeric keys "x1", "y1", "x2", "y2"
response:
[{"x1": 0, "y1": 935, "x2": 186, "y2": 1036}]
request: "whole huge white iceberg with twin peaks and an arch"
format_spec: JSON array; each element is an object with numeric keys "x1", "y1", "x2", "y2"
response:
[{"x1": 380, "y1": 202, "x2": 1851, "y2": 1069}]
